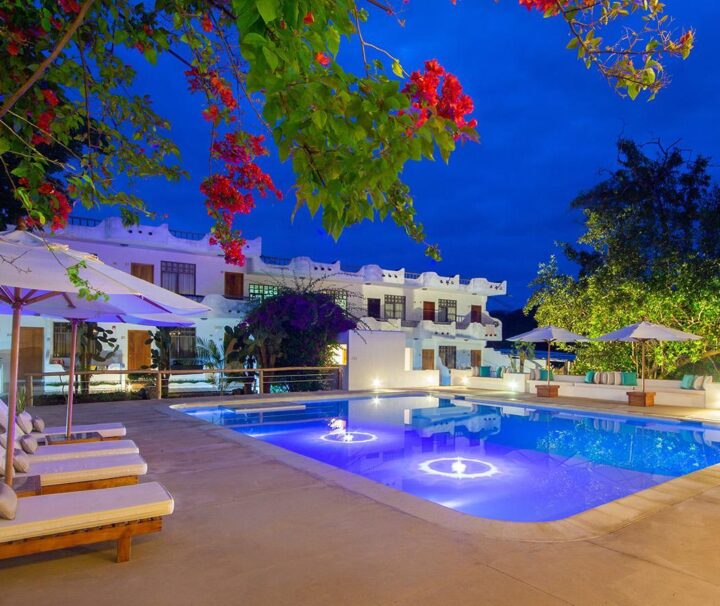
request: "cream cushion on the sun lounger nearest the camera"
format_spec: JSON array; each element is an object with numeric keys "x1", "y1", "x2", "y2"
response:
[{"x1": 0, "y1": 482, "x2": 174, "y2": 543}]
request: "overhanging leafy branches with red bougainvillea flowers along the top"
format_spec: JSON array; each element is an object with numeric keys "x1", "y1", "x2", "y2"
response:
[{"x1": 0, "y1": 0, "x2": 694, "y2": 276}]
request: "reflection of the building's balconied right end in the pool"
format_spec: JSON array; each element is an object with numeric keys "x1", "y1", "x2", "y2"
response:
[{"x1": 405, "y1": 405, "x2": 500, "y2": 440}]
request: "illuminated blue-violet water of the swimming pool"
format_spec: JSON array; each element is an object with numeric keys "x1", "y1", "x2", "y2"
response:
[{"x1": 180, "y1": 395, "x2": 720, "y2": 522}]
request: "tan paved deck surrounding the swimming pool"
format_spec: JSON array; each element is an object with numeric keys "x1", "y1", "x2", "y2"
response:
[{"x1": 0, "y1": 388, "x2": 720, "y2": 606}]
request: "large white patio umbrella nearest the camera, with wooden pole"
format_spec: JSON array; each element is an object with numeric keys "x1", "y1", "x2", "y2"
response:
[{"x1": 0, "y1": 230, "x2": 210, "y2": 486}]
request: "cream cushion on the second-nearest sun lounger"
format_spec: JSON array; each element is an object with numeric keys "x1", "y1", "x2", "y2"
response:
[{"x1": 18, "y1": 454, "x2": 147, "y2": 486}]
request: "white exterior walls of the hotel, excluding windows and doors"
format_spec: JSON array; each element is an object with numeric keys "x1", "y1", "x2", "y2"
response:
[{"x1": 0, "y1": 218, "x2": 506, "y2": 386}]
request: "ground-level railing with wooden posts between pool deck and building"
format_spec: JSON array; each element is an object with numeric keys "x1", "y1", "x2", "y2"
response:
[{"x1": 24, "y1": 366, "x2": 344, "y2": 406}]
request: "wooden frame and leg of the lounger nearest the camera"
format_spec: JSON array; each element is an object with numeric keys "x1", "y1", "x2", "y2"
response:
[{"x1": 0, "y1": 517, "x2": 162, "y2": 562}]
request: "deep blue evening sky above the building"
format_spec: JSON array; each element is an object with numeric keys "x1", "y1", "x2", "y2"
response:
[{"x1": 86, "y1": 0, "x2": 720, "y2": 308}]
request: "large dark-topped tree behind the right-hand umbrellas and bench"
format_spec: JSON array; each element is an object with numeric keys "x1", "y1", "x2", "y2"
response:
[{"x1": 526, "y1": 140, "x2": 720, "y2": 377}]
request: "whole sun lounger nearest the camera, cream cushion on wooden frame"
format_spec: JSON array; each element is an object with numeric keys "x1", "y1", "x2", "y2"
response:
[{"x1": 0, "y1": 482, "x2": 174, "y2": 562}]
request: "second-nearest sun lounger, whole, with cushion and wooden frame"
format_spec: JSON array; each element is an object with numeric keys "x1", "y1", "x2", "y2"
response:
[{"x1": 7, "y1": 454, "x2": 147, "y2": 494}]
